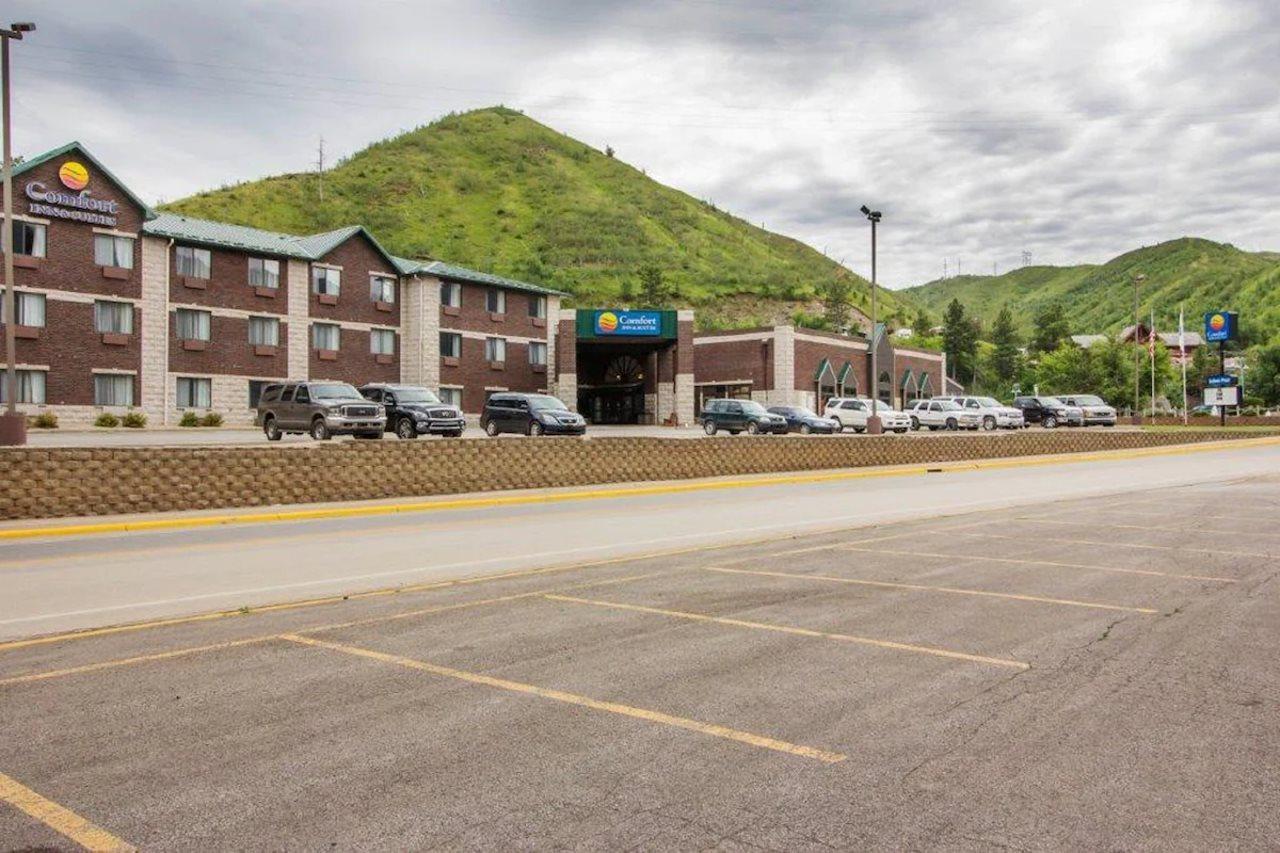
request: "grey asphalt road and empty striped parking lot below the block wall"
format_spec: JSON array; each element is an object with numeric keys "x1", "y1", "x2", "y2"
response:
[{"x1": 0, "y1": 447, "x2": 1280, "y2": 849}]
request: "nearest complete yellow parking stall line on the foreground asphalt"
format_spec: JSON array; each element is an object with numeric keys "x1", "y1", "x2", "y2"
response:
[{"x1": 282, "y1": 634, "x2": 847, "y2": 763}]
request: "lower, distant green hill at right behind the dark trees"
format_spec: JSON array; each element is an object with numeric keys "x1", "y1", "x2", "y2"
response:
[{"x1": 902, "y1": 237, "x2": 1280, "y2": 339}]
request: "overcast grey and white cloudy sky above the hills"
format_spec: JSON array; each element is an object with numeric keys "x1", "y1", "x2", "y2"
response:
[{"x1": 8, "y1": 0, "x2": 1280, "y2": 287}]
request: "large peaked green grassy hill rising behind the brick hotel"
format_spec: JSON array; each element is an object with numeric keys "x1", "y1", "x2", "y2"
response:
[{"x1": 165, "y1": 108, "x2": 913, "y2": 327}]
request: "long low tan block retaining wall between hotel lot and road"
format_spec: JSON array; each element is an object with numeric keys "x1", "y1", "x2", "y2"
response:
[{"x1": 0, "y1": 430, "x2": 1280, "y2": 519}]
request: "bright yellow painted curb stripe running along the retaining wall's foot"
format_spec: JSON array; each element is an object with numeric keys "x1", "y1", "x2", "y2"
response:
[{"x1": 0, "y1": 437, "x2": 1280, "y2": 540}]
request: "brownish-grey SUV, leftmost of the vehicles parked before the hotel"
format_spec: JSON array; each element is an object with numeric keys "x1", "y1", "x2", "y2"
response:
[{"x1": 253, "y1": 382, "x2": 387, "y2": 442}]
